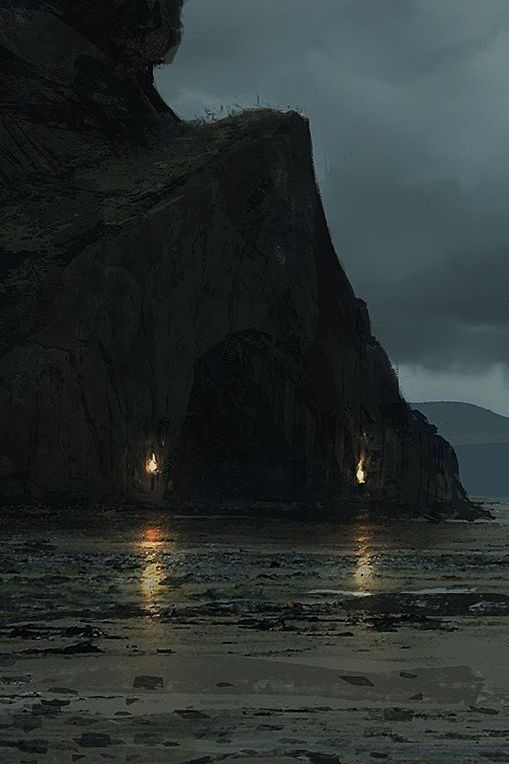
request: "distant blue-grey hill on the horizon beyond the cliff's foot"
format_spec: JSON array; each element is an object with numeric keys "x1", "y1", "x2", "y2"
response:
[{"x1": 411, "y1": 401, "x2": 509, "y2": 498}]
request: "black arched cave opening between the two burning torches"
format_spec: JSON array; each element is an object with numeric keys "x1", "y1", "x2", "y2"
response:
[{"x1": 174, "y1": 332, "x2": 305, "y2": 501}]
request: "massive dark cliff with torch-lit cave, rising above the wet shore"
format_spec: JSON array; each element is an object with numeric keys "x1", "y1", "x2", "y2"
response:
[{"x1": 0, "y1": 0, "x2": 466, "y2": 513}]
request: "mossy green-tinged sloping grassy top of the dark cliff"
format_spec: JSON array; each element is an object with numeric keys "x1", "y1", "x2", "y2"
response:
[{"x1": 0, "y1": 109, "x2": 310, "y2": 258}]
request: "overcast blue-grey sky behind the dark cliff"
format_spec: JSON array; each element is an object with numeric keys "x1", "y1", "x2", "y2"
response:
[{"x1": 157, "y1": 0, "x2": 509, "y2": 415}]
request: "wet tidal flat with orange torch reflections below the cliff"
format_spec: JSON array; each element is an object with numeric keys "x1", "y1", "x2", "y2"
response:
[{"x1": 0, "y1": 505, "x2": 509, "y2": 764}]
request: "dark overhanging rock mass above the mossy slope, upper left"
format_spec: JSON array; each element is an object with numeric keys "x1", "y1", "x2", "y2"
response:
[{"x1": 0, "y1": 0, "x2": 183, "y2": 184}]
